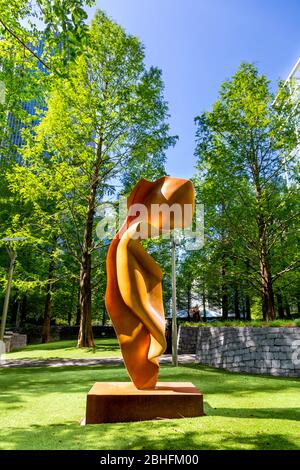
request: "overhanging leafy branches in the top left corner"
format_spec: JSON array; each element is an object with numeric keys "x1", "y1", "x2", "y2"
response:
[{"x1": 0, "y1": 0, "x2": 95, "y2": 75}]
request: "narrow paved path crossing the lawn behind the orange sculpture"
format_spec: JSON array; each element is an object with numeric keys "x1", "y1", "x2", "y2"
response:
[{"x1": 0, "y1": 354, "x2": 195, "y2": 368}]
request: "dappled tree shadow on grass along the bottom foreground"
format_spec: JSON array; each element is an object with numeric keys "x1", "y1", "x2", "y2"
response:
[{"x1": 0, "y1": 418, "x2": 299, "y2": 450}]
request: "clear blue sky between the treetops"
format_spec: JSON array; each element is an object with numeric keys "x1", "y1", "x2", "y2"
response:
[{"x1": 88, "y1": 0, "x2": 300, "y2": 178}]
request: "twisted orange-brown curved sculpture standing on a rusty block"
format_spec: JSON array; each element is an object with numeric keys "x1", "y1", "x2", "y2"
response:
[{"x1": 105, "y1": 176, "x2": 194, "y2": 389}]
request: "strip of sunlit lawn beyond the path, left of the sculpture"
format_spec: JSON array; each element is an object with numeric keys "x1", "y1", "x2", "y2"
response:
[{"x1": 6, "y1": 338, "x2": 121, "y2": 359}]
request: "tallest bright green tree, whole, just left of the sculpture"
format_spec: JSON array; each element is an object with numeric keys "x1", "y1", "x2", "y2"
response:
[{"x1": 7, "y1": 11, "x2": 174, "y2": 346}]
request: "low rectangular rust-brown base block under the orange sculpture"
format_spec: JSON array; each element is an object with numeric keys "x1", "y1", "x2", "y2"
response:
[{"x1": 85, "y1": 382, "x2": 204, "y2": 424}]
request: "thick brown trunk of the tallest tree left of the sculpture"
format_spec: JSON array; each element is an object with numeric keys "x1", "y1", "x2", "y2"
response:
[{"x1": 77, "y1": 135, "x2": 103, "y2": 348}]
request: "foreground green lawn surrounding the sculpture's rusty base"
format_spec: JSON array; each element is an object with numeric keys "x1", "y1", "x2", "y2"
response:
[{"x1": 0, "y1": 365, "x2": 300, "y2": 450}]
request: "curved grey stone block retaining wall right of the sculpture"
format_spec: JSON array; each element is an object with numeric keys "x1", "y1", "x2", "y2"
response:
[{"x1": 178, "y1": 327, "x2": 300, "y2": 377}]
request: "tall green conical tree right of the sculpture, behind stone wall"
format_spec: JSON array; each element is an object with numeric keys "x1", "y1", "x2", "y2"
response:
[{"x1": 196, "y1": 64, "x2": 299, "y2": 319}]
